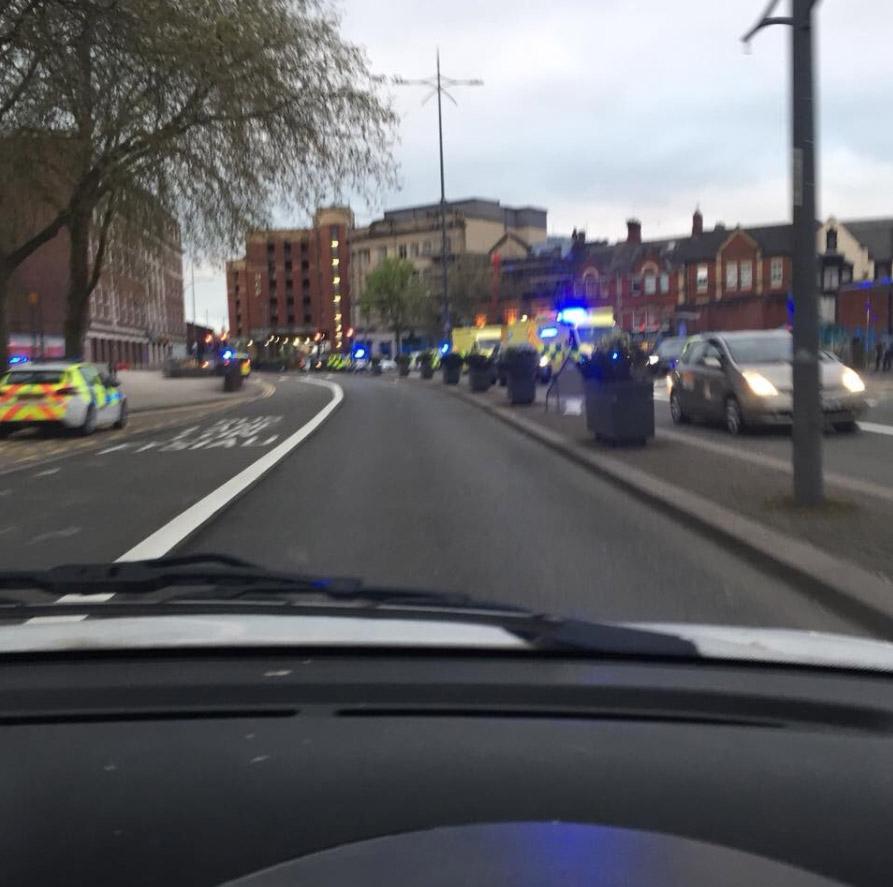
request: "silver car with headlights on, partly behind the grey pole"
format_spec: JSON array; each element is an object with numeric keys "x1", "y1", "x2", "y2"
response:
[{"x1": 668, "y1": 330, "x2": 867, "y2": 434}]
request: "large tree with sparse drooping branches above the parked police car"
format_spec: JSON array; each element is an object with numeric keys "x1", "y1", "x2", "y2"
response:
[{"x1": 0, "y1": 0, "x2": 394, "y2": 354}]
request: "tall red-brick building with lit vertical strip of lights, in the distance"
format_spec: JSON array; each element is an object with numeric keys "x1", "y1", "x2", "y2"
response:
[{"x1": 226, "y1": 207, "x2": 353, "y2": 349}]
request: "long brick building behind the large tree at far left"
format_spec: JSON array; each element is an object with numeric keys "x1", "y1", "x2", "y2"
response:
[{"x1": 7, "y1": 210, "x2": 186, "y2": 366}]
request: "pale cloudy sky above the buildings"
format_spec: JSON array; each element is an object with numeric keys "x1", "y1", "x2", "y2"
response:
[{"x1": 187, "y1": 0, "x2": 893, "y2": 324}]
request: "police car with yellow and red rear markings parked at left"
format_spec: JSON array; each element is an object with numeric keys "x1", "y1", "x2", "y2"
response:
[{"x1": 0, "y1": 361, "x2": 127, "y2": 436}]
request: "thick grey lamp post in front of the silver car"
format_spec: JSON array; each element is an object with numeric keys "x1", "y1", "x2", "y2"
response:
[{"x1": 742, "y1": 0, "x2": 824, "y2": 505}]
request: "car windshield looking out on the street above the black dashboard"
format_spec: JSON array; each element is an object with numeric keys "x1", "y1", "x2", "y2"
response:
[{"x1": 0, "y1": 0, "x2": 893, "y2": 661}]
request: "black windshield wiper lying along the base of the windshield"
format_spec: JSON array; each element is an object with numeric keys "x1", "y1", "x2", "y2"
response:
[{"x1": 0, "y1": 555, "x2": 700, "y2": 658}]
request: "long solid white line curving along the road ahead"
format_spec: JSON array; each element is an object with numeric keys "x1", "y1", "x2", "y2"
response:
[{"x1": 118, "y1": 379, "x2": 344, "y2": 562}]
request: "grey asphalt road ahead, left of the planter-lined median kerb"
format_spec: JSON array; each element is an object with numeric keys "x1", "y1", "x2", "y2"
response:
[{"x1": 0, "y1": 376, "x2": 866, "y2": 633}]
